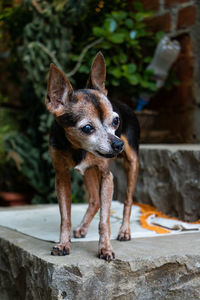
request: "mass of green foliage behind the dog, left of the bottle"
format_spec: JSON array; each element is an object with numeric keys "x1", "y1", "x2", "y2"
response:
[{"x1": 0, "y1": 0, "x2": 164, "y2": 203}]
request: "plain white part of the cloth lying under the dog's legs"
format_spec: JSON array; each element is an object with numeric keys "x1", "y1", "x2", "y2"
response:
[{"x1": 0, "y1": 201, "x2": 155, "y2": 242}]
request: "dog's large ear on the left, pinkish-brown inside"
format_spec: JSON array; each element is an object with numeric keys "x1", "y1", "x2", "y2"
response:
[{"x1": 45, "y1": 64, "x2": 73, "y2": 116}]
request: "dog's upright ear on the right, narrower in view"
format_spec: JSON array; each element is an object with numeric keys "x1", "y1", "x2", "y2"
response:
[{"x1": 86, "y1": 52, "x2": 107, "y2": 95}]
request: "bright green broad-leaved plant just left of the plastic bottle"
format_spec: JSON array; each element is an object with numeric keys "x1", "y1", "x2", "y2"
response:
[{"x1": 71, "y1": 3, "x2": 162, "y2": 96}]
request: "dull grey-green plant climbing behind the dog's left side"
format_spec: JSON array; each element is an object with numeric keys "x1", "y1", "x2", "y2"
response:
[{"x1": 1, "y1": 1, "x2": 89, "y2": 203}]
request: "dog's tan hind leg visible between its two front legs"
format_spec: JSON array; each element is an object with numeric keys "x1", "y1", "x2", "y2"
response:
[{"x1": 74, "y1": 168, "x2": 100, "y2": 238}]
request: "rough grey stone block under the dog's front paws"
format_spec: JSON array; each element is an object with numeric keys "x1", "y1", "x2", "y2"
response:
[{"x1": 0, "y1": 227, "x2": 200, "y2": 300}]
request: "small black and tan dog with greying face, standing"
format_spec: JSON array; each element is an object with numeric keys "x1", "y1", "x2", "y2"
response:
[{"x1": 45, "y1": 52, "x2": 139, "y2": 261}]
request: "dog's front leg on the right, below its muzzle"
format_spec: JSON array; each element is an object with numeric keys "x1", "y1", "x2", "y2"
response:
[{"x1": 98, "y1": 172, "x2": 115, "y2": 261}]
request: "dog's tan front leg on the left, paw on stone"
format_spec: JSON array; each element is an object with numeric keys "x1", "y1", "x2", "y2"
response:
[{"x1": 51, "y1": 170, "x2": 71, "y2": 256}]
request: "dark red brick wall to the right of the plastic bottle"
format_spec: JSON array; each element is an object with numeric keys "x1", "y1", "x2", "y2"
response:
[{"x1": 132, "y1": 0, "x2": 200, "y2": 143}]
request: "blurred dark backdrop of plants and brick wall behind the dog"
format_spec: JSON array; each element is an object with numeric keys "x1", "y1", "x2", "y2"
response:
[{"x1": 0, "y1": 0, "x2": 200, "y2": 205}]
